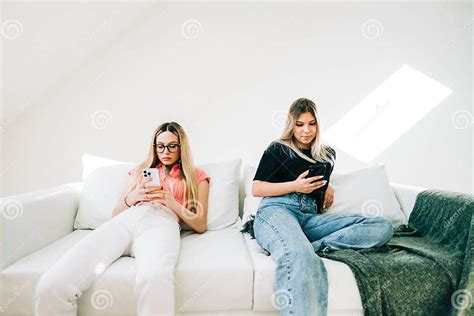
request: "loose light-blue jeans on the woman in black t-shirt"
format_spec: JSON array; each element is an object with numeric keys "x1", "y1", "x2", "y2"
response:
[{"x1": 254, "y1": 192, "x2": 393, "y2": 316}]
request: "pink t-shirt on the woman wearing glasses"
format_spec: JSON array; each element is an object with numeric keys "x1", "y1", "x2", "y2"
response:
[{"x1": 128, "y1": 163, "x2": 211, "y2": 224}]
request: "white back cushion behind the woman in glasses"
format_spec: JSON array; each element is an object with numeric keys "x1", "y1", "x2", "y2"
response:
[{"x1": 74, "y1": 155, "x2": 241, "y2": 230}]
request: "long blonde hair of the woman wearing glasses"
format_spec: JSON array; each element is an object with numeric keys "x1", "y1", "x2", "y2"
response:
[{"x1": 129, "y1": 122, "x2": 198, "y2": 212}]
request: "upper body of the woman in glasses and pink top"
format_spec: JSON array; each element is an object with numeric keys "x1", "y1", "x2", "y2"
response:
[{"x1": 123, "y1": 122, "x2": 210, "y2": 233}]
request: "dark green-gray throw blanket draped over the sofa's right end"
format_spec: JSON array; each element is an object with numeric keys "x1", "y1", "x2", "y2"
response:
[{"x1": 242, "y1": 190, "x2": 474, "y2": 316}]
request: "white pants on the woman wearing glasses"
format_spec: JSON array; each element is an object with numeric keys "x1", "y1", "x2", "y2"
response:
[{"x1": 34, "y1": 204, "x2": 181, "y2": 316}]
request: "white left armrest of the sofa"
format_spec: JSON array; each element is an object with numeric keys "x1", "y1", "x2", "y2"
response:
[{"x1": 0, "y1": 182, "x2": 82, "y2": 270}]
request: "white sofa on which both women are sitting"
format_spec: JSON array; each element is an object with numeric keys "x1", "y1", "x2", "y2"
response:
[{"x1": 0, "y1": 165, "x2": 422, "y2": 316}]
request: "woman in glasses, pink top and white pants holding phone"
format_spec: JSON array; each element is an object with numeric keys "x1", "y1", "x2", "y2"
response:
[{"x1": 34, "y1": 122, "x2": 210, "y2": 316}]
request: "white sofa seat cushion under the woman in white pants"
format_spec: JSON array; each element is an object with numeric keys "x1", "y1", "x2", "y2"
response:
[{"x1": 0, "y1": 225, "x2": 253, "y2": 315}]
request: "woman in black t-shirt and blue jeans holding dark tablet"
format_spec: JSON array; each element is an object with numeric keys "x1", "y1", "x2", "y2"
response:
[{"x1": 248, "y1": 98, "x2": 393, "y2": 316}]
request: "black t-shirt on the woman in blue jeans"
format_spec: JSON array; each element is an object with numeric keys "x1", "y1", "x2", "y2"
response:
[{"x1": 253, "y1": 141, "x2": 336, "y2": 213}]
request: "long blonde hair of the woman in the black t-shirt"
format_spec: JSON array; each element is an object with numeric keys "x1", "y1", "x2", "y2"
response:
[{"x1": 276, "y1": 98, "x2": 335, "y2": 165}]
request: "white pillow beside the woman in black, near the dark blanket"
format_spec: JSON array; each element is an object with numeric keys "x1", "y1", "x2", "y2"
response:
[{"x1": 326, "y1": 163, "x2": 407, "y2": 226}]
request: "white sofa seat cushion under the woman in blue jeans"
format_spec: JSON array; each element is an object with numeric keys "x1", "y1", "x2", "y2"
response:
[{"x1": 244, "y1": 234, "x2": 363, "y2": 315}]
